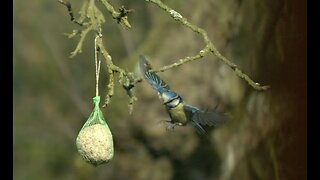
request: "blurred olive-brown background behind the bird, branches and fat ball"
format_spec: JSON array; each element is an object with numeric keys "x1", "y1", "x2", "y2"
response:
[{"x1": 13, "y1": 0, "x2": 307, "y2": 180}]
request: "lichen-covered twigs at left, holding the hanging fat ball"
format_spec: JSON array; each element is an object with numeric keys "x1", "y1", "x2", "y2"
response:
[{"x1": 58, "y1": 0, "x2": 136, "y2": 112}]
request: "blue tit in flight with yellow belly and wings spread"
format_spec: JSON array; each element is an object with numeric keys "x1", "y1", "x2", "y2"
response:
[{"x1": 140, "y1": 55, "x2": 224, "y2": 134}]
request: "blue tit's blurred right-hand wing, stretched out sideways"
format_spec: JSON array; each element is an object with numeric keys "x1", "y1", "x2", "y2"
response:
[{"x1": 185, "y1": 104, "x2": 225, "y2": 126}]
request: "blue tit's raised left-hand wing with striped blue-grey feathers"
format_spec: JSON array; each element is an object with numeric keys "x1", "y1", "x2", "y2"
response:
[{"x1": 140, "y1": 55, "x2": 170, "y2": 93}]
